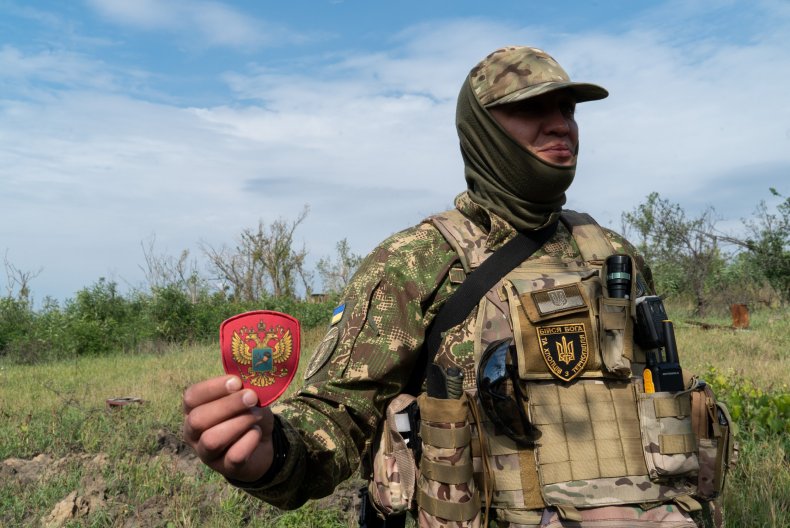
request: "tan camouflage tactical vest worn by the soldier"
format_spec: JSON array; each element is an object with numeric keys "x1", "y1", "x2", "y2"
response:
[{"x1": 428, "y1": 210, "x2": 699, "y2": 526}]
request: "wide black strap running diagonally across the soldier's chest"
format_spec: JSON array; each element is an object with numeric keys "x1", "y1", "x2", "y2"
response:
[{"x1": 405, "y1": 222, "x2": 557, "y2": 394}]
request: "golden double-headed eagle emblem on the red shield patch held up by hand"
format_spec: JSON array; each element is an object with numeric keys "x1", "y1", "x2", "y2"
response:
[{"x1": 231, "y1": 321, "x2": 293, "y2": 387}]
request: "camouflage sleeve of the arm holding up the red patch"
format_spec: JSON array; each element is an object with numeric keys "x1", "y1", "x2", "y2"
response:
[{"x1": 235, "y1": 224, "x2": 457, "y2": 509}]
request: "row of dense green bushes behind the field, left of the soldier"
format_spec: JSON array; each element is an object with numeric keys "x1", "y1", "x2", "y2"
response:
[{"x1": 0, "y1": 279, "x2": 337, "y2": 364}]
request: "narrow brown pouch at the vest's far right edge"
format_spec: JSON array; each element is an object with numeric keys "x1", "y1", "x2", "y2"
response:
[{"x1": 691, "y1": 386, "x2": 738, "y2": 499}]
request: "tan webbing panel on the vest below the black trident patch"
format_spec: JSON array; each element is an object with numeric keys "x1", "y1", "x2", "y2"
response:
[{"x1": 528, "y1": 381, "x2": 647, "y2": 484}]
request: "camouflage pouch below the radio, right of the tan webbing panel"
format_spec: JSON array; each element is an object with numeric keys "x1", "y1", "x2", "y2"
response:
[{"x1": 637, "y1": 392, "x2": 699, "y2": 480}]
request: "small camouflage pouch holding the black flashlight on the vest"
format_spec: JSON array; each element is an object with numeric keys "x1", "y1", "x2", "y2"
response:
[{"x1": 598, "y1": 297, "x2": 634, "y2": 378}]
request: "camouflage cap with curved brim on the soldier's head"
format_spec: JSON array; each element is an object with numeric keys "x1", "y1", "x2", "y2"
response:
[{"x1": 469, "y1": 46, "x2": 609, "y2": 107}]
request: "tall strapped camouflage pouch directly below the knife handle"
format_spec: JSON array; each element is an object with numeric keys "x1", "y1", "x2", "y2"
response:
[{"x1": 417, "y1": 393, "x2": 481, "y2": 528}]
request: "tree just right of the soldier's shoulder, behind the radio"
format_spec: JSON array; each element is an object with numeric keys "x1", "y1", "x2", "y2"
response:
[{"x1": 622, "y1": 192, "x2": 725, "y2": 315}]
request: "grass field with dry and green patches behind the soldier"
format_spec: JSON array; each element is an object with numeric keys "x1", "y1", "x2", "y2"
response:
[{"x1": 0, "y1": 310, "x2": 790, "y2": 528}]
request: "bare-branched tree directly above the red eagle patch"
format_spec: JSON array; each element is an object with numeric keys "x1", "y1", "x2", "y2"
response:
[{"x1": 203, "y1": 206, "x2": 311, "y2": 301}]
